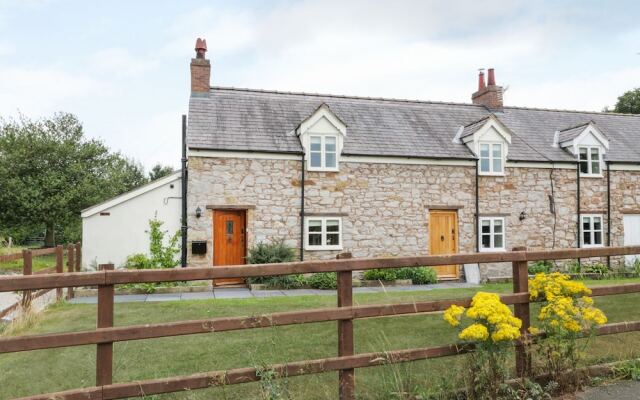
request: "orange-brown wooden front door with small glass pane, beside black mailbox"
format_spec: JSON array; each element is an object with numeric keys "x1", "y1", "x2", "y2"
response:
[{"x1": 213, "y1": 210, "x2": 247, "y2": 285}]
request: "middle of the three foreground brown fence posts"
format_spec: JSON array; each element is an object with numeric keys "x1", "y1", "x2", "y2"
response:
[{"x1": 336, "y1": 253, "x2": 356, "y2": 400}]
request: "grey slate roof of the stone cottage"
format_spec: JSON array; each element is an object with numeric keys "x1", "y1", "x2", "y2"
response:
[{"x1": 187, "y1": 87, "x2": 640, "y2": 162}]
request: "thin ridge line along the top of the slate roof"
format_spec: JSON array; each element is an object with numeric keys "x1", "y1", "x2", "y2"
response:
[{"x1": 209, "y1": 86, "x2": 640, "y2": 118}]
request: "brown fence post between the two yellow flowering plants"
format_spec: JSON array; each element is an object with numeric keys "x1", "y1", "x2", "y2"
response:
[{"x1": 511, "y1": 247, "x2": 531, "y2": 377}]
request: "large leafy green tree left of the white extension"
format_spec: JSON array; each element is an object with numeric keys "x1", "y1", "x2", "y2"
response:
[{"x1": 0, "y1": 113, "x2": 145, "y2": 246}]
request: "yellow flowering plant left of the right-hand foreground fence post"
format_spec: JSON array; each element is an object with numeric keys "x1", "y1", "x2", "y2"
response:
[{"x1": 443, "y1": 292, "x2": 522, "y2": 399}]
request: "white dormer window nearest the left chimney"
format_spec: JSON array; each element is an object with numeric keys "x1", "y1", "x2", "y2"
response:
[{"x1": 296, "y1": 104, "x2": 347, "y2": 171}]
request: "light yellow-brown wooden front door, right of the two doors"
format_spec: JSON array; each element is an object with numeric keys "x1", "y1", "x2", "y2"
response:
[{"x1": 429, "y1": 210, "x2": 460, "y2": 279}]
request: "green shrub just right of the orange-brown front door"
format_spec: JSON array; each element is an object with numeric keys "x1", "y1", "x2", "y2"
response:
[{"x1": 247, "y1": 239, "x2": 306, "y2": 289}]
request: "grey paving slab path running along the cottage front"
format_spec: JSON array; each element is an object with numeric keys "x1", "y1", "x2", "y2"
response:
[{"x1": 69, "y1": 282, "x2": 480, "y2": 304}]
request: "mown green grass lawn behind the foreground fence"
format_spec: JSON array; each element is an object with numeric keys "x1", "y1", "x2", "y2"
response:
[{"x1": 0, "y1": 279, "x2": 640, "y2": 399}]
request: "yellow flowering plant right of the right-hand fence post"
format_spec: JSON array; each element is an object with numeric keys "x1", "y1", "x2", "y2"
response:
[{"x1": 529, "y1": 272, "x2": 607, "y2": 391}]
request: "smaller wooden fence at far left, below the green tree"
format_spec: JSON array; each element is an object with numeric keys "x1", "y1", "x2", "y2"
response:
[{"x1": 0, "y1": 242, "x2": 82, "y2": 318}]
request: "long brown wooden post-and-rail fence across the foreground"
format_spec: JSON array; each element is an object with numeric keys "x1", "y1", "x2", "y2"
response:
[{"x1": 0, "y1": 246, "x2": 640, "y2": 400}]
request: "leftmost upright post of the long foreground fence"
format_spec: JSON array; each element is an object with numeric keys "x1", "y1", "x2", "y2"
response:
[{"x1": 96, "y1": 264, "x2": 114, "y2": 386}]
